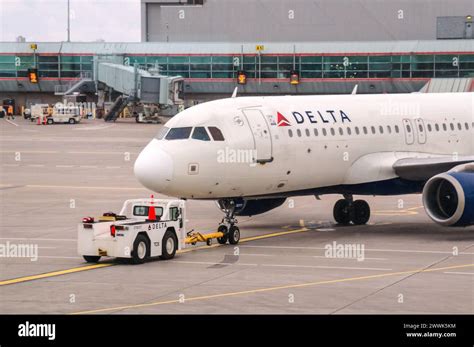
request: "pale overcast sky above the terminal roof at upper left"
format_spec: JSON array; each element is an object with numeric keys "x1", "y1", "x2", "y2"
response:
[{"x1": 0, "y1": 0, "x2": 140, "y2": 42}]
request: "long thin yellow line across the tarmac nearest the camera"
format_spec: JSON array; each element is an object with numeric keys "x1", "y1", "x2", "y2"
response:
[{"x1": 71, "y1": 264, "x2": 474, "y2": 315}]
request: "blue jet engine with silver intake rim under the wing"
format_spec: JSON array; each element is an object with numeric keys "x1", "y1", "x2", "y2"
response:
[{"x1": 423, "y1": 167, "x2": 474, "y2": 226}]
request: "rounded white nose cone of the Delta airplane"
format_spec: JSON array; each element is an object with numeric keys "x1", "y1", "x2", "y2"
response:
[{"x1": 134, "y1": 140, "x2": 173, "y2": 193}]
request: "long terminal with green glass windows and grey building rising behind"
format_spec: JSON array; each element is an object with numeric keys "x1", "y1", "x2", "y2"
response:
[{"x1": 0, "y1": 0, "x2": 474, "y2": 111}]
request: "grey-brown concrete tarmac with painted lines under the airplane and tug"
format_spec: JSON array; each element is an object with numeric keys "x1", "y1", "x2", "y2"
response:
[{"x1": 0, "y1": 117, "x2": 474, "y2": 314}]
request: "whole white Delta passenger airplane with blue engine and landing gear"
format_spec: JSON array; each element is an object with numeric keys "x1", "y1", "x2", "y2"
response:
[{"x1": 134, "y1": 93, "x2": 474, "y2": 244}]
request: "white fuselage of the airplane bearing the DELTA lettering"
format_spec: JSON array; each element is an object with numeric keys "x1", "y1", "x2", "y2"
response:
[{"x1": 135, "y1": 93, "x2": 474, "y2": 199}]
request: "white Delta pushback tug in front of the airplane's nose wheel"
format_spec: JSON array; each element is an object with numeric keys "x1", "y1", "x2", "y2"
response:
[{"x1": 78, "y1": 198, "x2": 186, "y2": 264}]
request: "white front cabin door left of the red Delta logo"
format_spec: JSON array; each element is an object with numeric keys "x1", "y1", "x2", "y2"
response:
[{"x1": 242, "y1": 109, "x2": 273, "y2": 163}]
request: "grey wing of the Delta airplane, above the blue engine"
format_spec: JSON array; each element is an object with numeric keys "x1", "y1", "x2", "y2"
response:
[{"x1": 393, "y1": 156, "x2": 474, "y2": 181}]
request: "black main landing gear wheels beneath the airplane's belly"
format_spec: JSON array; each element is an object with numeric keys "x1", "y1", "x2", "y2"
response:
[{"x1": 333, "y1": 195, "x2": 370, "y2": 225}]
